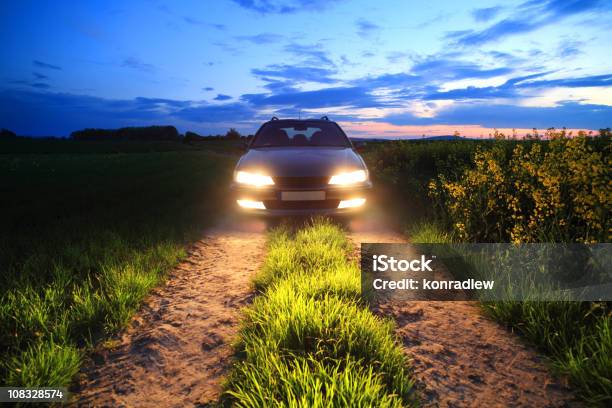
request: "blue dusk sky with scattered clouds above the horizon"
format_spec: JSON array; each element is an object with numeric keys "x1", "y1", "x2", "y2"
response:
[{"x1": 0, "y1": 0, "x2": 612, "y2": 137}]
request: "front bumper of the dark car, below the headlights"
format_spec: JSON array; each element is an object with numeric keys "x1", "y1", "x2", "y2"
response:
[{"x1": 231, "y1": 181, "x2": 372, "y2": 216}]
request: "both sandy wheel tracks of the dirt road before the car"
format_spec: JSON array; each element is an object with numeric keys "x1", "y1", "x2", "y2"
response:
[{"x1": 78, "y1": 209, "x2": 576, "y2": 407}]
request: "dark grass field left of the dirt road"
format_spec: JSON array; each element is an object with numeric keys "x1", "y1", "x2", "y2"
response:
[{"x1": 0, "y1": 142, "x2": 233, "y2": 386}]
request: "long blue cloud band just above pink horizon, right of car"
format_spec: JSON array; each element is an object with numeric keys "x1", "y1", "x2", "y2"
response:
[{"x1": 381, "y1": 102, "x2": 612, "y2": 129}]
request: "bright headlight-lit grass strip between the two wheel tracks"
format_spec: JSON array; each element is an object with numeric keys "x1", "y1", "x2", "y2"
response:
[{"x1": 225, "y1": 220, "x2": 416, "y2": 407}]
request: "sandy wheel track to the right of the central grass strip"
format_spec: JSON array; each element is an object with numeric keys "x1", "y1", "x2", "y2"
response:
[{"x1": 349, "y1": 215, "x2": 578, "y2": 407}]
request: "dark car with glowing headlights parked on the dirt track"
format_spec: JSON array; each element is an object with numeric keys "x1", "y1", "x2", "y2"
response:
[{"x1": 231, "y1": 116, "x2": 372, "y2": 216}]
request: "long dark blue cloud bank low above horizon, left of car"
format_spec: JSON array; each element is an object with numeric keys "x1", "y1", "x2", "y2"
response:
[{"x1": 0, "y1": 89, "x2": 258, "y2": 136}]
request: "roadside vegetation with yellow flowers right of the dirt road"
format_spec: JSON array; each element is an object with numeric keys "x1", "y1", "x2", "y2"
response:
[{"x1": 365, "y1": 129, "x2": 612, "y2": 405}]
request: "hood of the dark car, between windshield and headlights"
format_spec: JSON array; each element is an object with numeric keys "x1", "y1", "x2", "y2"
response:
[{"x1": 236, "y1": 147, "x2": 366, "y2": 177}]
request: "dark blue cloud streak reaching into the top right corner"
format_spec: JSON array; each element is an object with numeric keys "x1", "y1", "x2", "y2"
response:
[{"x1": 447, "y1": 0, "x2": 612, "y2": 46}]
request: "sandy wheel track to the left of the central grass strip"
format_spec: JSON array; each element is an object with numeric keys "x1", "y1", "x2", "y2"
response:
[{"x1": 77, "y1": 221, "x2": 265, "y2": 407}]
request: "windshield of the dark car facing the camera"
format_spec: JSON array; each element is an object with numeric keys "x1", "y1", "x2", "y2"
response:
[{"x1": 251, "y1": 123, "x2": 350, "y2": 148}]
